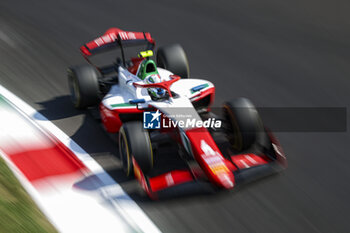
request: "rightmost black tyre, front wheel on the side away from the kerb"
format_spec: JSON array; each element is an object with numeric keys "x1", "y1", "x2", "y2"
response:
[{"x1": 223, "y1": 98, "x2": 264, "y2": 151}]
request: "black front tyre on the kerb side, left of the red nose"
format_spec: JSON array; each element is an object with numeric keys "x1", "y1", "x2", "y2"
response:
[{"x1": 119, "y1": 121, "x2": 153, "y2": 176}]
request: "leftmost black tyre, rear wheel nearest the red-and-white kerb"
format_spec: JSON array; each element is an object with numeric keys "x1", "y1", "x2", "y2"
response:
[{"x1": 67, "y1": 64, "x2": 100, "y2": 109}]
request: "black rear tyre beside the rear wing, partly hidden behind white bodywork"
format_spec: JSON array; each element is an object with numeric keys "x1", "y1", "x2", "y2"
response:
[{"x1": 157, "y1": 44, "x2": 190, "y2": 78}]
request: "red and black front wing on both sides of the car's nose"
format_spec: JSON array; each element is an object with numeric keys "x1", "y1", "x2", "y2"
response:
[{"x1": 133, "y1": 133, "x2": 287, "y2": 199}]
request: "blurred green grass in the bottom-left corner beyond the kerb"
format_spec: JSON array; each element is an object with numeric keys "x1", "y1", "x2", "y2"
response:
[{"x1": 0, "y1": 158, "x2": 57, "y2": 233}]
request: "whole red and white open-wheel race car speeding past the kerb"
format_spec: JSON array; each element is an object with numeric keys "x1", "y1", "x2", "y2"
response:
[{"x1": 68, "y1": 28, "x2": 287, "y2": 199}]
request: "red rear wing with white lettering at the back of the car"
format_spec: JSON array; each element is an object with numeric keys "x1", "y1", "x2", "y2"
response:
[{"x1": 80, "y1": 28, "x2": 155, "y2": 58}]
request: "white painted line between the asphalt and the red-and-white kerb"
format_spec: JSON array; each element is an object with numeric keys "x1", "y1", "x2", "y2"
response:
[{"x1": 0, "y1": 85, "x2": 160, "y2": 233}]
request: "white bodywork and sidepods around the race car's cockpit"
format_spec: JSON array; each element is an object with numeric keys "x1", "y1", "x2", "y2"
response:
[{"x1": 102, "y1": 67, "x2": 214, "y2": 124}]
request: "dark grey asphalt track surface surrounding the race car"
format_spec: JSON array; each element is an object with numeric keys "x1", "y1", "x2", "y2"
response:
[{"x1": 0, "y1": 0, "x2": 350, "y2": 233}]
